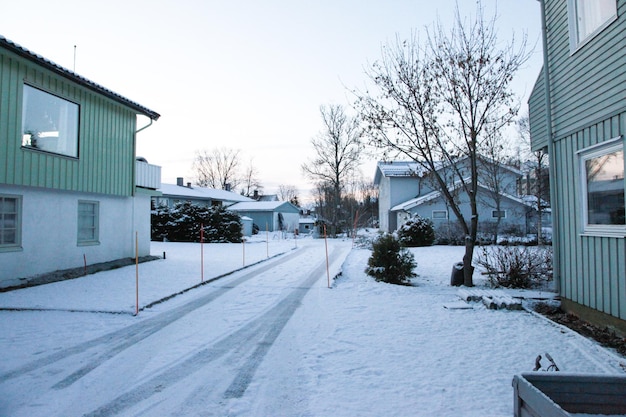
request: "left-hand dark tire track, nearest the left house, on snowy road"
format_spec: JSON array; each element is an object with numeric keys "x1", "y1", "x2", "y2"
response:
[{"x1": 0, "y1": 247, "x2": 308, "y2": 389}]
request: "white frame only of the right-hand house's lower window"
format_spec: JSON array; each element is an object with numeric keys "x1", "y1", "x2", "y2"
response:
[{"x1": 578, "y1": 136, "x2": 626, "y2": 237}]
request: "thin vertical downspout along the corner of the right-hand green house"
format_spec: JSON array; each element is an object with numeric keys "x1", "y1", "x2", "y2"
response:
[{"x1": 538, "y1": 0, "x2": 561, "y2": 294}]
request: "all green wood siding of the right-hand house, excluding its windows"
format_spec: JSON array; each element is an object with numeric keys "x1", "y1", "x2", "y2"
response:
[{"x1": 529, "y1": 0, "x2": 626, "y2": 320}]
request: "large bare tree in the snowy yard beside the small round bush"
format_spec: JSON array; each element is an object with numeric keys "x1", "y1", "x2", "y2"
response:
[{"x1": 355, "y1": 3, "x2": 528, "y2": 286}]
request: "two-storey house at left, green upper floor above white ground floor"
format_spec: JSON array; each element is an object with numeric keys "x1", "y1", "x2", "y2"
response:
[{"x1": 0, "y1": 36, "x2": 161, "y2": 287}]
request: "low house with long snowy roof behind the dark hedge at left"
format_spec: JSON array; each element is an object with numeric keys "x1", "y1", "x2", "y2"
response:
[{"x1": 152, "y1": 177, "x2": 254, "y2": 208}]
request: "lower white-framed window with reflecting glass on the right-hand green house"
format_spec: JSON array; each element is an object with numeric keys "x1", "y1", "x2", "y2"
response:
[{"x1": 580, "y1": 138, "x2": 626, "y2": 234}]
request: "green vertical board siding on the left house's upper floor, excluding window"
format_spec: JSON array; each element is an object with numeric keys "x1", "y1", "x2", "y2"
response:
[{"x1": 0, "y1": 44, "x2": 136, "y2": 196}]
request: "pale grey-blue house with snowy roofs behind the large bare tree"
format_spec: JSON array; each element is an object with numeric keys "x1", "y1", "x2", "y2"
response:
[{"x1": 374, "y1": 159, "x2": 534, "y2": 239}]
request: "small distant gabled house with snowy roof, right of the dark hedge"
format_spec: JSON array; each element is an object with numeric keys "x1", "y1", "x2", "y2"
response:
[{"x1": 228, "y1": 201, "x2": 300, "y2": 232}]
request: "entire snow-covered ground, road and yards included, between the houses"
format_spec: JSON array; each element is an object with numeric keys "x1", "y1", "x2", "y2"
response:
[{"x1": 0, "y1": 237, "x2": 626, "y2": 417}]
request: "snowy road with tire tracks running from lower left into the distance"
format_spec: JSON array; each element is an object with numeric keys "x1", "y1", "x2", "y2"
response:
[{"x1": 0, "y1": 237, "x2": 350, "y2": 416}]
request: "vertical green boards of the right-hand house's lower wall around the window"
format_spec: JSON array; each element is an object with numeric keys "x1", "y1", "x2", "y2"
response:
[{"x1": 554, "y1": 112, "x2": 626, "y2": 319}]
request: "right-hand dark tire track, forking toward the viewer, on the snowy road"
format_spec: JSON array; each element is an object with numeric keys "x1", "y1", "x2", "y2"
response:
[{"x1": 84, "y1": 242, "x2": 346, "y2": 417}]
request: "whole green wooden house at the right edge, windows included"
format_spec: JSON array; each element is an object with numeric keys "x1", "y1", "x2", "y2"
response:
[{"x1": 529, "y1": 0, "x2": 626, "y2": 332}]
